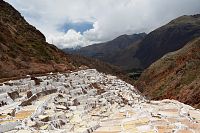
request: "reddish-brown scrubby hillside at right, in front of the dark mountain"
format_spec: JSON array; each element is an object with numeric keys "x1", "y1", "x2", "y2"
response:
[{"x1": 136, "y1": 38, "x2": 200, "y2": 108}]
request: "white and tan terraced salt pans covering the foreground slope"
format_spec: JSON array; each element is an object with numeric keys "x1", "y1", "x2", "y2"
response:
[{"x1": 0, "y1": 69, "x2": 200, "y2": 133}]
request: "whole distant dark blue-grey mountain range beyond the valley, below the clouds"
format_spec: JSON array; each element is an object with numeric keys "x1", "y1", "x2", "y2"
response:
[{"x1": 68, "y1": 15, "x2": 200, "y2": 70}]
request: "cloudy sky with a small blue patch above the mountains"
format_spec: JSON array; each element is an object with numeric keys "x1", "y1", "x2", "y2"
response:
[{"x1": 5, "y1": 0, "x2": 200, "y2": 49}]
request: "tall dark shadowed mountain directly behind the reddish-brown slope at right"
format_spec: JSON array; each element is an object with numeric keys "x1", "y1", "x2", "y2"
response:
[{"x1": 134, "y1": 14, "x2": 200, "y2": 68}]
